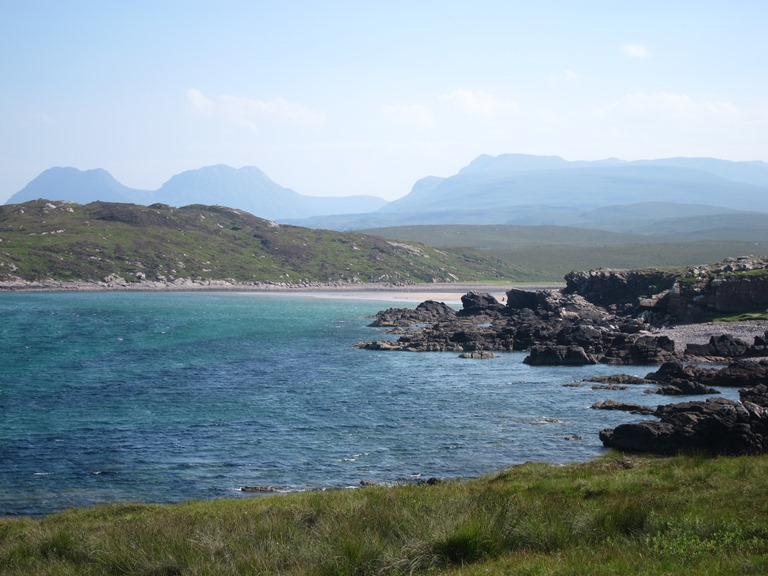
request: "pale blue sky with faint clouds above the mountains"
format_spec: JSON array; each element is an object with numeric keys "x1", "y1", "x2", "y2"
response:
[{"x1": 0, "y1": 0, "x2": 768, "y2": 203}]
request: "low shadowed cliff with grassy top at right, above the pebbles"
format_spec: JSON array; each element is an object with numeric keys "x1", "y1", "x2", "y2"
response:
[{"x1": 564, "y1": 257, "x2": 768, "y2": 322}]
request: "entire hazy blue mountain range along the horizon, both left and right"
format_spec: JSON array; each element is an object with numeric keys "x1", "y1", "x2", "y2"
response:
[{"x1": 8, "y1": 154, "x2": 768, "y2": 235}]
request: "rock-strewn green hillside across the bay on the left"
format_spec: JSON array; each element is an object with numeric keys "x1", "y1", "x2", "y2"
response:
[{"x1": 0, "y1": 200, "x2": 528, "y2": 283}]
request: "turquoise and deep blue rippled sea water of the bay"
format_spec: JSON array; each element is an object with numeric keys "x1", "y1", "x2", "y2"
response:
[{"x1": 0, "y1": 292, "x2": 736, "y2": 516}]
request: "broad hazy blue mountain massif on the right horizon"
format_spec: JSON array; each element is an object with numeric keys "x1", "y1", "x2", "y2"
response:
[{"x1": 282, "y1": 154, "x2": 768, "y2": 239}]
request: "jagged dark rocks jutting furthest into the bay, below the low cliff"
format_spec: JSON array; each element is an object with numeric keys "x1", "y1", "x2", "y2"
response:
[{"x1": 358, "y1": 290, "x2": 675, "y2": 365}]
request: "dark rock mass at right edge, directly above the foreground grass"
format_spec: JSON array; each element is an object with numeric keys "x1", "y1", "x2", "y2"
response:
[{"x1": 600, "y1": 385, "x2": 768, "y2": 455}]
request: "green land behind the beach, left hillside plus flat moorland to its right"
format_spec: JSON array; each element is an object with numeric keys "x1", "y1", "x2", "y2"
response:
[{"x1": 0, "y1": 200, "x2": 763, "y2": 285}]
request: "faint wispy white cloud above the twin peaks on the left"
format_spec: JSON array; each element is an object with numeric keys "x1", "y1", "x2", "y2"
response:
[{"x1": 187, "y1": 88, "x2": 326, "y2": 131}]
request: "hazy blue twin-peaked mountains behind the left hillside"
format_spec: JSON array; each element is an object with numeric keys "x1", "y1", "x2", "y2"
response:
[{"x1": 6, "y1": 165, "x2": 386, "y2": 220}]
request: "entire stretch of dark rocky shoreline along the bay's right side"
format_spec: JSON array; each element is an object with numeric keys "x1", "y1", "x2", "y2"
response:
[{"x1": 358, "y1": 260, "x2": 768, "y2": 454}]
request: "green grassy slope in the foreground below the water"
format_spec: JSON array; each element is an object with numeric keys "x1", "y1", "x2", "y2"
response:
[{"x1": 0, "y1": 455, "x2": 768, "y2": 576}]
